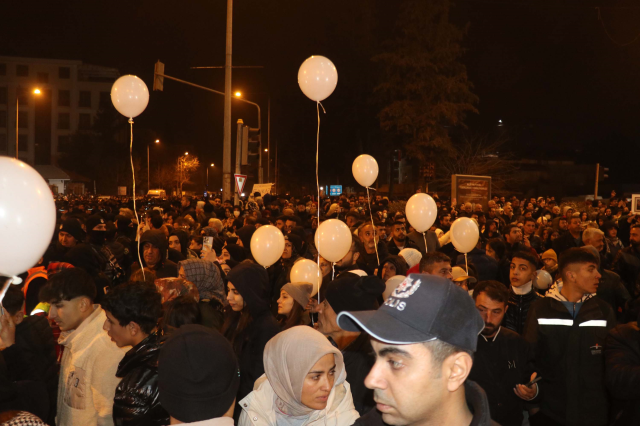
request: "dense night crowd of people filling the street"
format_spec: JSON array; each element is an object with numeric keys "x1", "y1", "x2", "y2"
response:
[{"x1": 0, "y1": 193, "x2": 640, "y2": 426}]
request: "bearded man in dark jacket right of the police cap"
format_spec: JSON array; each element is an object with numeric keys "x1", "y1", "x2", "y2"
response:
[{"x1": 469, "y1": 281, "x2": 538, "y2": 426}]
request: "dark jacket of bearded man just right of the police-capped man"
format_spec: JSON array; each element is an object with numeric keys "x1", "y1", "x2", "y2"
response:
[{"x1": 469, "y1": 327, "x2": 534, "y2": 426}]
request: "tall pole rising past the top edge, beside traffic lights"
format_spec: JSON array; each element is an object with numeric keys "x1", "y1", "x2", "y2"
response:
[{"x1": 222, "y1": 0, "x2": 238, "y2": 204}]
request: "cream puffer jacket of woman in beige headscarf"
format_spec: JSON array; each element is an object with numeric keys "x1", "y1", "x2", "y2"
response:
[{"x1": 238, "y1": 375, "x2": 360, "y2": 426}]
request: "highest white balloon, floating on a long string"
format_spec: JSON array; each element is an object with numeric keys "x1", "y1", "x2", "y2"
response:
[{"x1": 298, "y1": 56, "x2": 338, "y2": 102}]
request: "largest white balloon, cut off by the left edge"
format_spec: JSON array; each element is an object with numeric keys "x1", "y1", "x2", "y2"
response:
[{"x1": 0, "y1": 157, "x2": 56, "y2": 276}]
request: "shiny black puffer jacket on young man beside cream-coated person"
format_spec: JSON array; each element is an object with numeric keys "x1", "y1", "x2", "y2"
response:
[{"x1": 113, "y1": 332, "x2": 169, "y2": 426}]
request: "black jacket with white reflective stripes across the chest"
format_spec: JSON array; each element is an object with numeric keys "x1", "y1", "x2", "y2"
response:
[{"x1": 523, "y1": 297, "x2": 615, "y2": 426}]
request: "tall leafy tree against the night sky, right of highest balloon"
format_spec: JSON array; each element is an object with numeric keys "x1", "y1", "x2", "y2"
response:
[{"x1": 373, "y1": 0, "x2": 478, "y2": 161}]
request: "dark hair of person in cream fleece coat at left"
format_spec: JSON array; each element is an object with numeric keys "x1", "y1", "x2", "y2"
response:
[{"x1": 39, "y1": 268, "x2": 96, "y2": 304}]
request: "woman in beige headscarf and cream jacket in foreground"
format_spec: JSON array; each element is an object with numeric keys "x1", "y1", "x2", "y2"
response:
[{"x1": 238, "y1": 326, "x2": 359, "y2": 426}]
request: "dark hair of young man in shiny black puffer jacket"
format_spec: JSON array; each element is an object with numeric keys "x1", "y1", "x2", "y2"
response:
[{"x1": 101, "y1": 281, "x2": 162, "y2": 334}]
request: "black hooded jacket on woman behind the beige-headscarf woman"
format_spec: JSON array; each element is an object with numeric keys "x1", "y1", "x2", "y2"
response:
[{"x1": 225, "y1": 262, "x2": 280, "y2": 410}]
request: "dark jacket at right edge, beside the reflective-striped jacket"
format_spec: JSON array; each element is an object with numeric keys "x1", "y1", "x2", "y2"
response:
[{"x1": 604, "y1": 322, "x2": 640, "y2": 425}]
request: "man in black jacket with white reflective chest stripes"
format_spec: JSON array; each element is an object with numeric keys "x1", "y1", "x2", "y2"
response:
[{"x1": 524, "y1": 248, "x2": 615, "y2": 426}]
